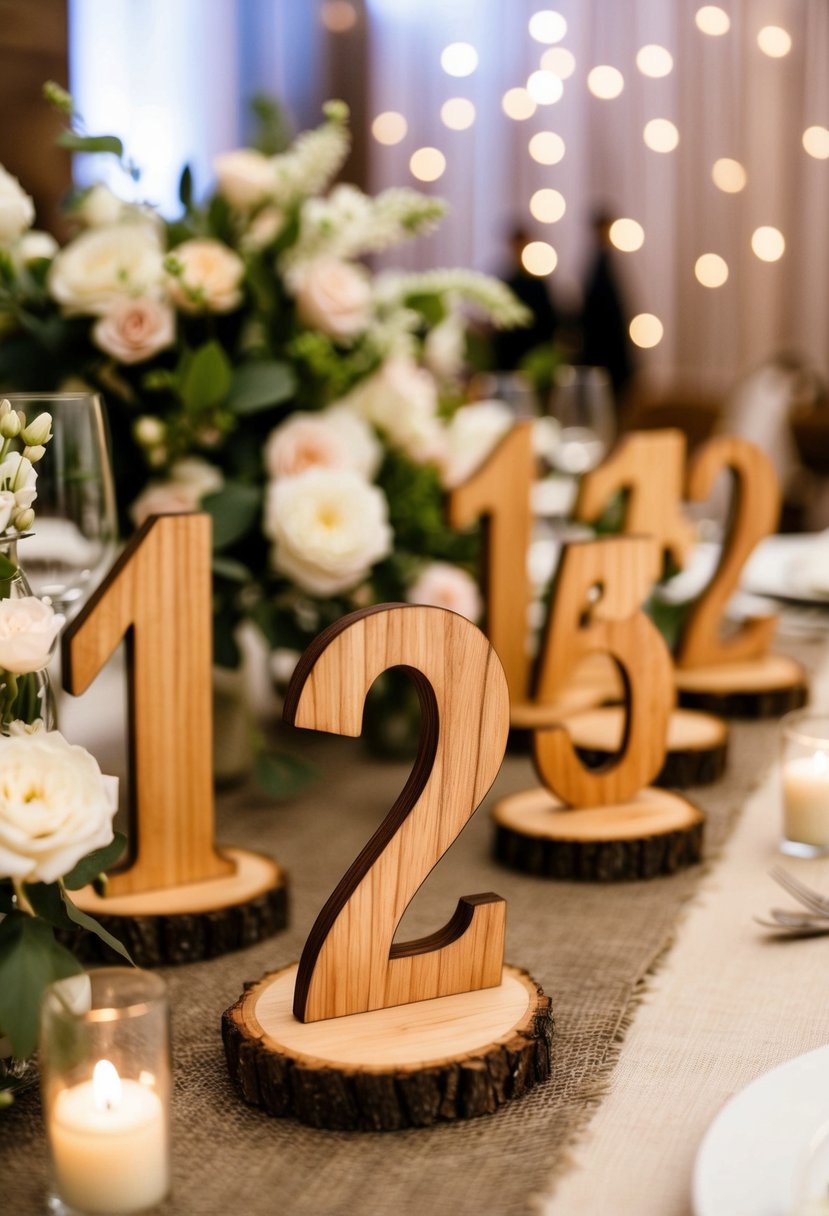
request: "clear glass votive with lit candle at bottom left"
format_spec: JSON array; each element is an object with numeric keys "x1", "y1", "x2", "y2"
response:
[{"x1": 39, "y1": 967, "x2": 170, "y2": 1216}]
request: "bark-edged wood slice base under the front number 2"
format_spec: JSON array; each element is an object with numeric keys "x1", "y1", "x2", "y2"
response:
[{"x1": 222, "y1": 963, "x2": 553, "y2": 1131}]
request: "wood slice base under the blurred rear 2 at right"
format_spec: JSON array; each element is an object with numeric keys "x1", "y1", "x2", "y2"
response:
[{"x1": 676, "y1": 654, "x2": 808, "y2": 717}]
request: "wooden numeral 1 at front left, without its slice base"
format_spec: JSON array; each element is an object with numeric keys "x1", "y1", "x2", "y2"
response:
[{"x1": 63, "y1": 514, "x2": 235, "y2": 895}]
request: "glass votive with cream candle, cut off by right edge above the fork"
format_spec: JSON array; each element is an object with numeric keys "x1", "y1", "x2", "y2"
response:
[{"x1": 780, "y1": 709, "x2": 829, "y2": 857}]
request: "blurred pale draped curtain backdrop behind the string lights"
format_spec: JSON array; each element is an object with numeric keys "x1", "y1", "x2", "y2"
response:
[{"x1": 71, "y1": 0, "x2": 829, "y2": 392}]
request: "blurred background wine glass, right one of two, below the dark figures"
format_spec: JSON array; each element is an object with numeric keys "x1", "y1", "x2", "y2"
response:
[{"x1": 549, "y1": 365, "x2": 616, "y2": 477}]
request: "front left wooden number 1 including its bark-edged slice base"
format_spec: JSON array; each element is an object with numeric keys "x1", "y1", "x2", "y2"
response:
[{"x1": 63, "y1": 514, "x2": 287, "y2": 967}]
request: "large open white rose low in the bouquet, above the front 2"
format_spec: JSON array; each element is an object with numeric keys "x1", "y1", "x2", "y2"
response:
[{"x1": 265, "y1": 468, "x2": 393, "y2": 596}]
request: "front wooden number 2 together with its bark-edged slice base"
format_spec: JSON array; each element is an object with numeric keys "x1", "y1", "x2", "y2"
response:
[{"x1": 222, "y1": 604, "x2": 552, "y2": 1131}]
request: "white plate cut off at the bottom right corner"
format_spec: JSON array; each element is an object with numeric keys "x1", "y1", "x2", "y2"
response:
[{"x1": 693, "y1": 1047, "x2": 829, "y2": 1216}]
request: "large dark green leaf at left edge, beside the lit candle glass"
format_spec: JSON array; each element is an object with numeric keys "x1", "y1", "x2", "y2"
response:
[{"x1": 0, "y1": 912, "x2": 84, "y2": 1059}]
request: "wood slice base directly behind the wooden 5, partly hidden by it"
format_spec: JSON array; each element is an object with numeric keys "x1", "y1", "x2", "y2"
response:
[{"x1": 566, "y1": 705, "x2": 728, "y2": 789}]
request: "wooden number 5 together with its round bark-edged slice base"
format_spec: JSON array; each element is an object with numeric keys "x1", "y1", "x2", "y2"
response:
[{"x1": 494, "y1": 536, "x2": 704, "y2": 879}]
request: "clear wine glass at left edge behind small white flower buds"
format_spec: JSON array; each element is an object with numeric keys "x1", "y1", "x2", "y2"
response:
[{"x1": 6, "y1": 393, "x2": 118, "y2": 614}]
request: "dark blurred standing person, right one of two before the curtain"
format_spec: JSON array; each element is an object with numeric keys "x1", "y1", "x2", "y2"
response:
[{"x1": 581, "y1": 210, "x2": 635, "y2": 413}]
